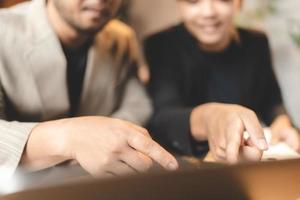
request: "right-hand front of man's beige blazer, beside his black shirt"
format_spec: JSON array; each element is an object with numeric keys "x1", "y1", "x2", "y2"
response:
[{"x1": 79, "y1": 34, "x2": 116, "y2": 115}]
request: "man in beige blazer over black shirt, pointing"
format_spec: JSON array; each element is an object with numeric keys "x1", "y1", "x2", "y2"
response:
[{"x1": 0, "y1": 0, "x2": 177, "y2": 176}]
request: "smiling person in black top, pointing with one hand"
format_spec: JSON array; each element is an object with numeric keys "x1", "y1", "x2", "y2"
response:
[{"x1": 145, "y1": 0, "x2": 300, "y2": 163}]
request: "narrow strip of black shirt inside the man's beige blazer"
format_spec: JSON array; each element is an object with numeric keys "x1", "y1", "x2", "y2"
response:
[{"x1": 63, "y1": 41, "x2": 91, "y2": 117}]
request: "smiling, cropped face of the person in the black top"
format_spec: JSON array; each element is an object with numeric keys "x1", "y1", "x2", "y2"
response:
[{"x1": 177, "y1": 0, "x2": 239, "y2": 48}]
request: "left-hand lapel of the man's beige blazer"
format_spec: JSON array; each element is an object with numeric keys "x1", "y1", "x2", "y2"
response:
[{"x1": 25, "y1": 0, "x2": 70, "y2": 119}]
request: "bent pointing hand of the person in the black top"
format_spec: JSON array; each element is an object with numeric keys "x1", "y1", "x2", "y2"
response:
[{"x1": 190, "y1": 103, "x2": 268, "y2": 164}]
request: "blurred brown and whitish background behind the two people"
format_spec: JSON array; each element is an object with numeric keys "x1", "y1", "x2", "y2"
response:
[{"x1": 0, "y1": 0, "x2": 300, "y2": 127}]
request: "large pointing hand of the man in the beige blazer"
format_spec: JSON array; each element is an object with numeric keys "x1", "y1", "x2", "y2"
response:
[{"x1": 69, "y1": 117, "x2": 177, "y2": 175}]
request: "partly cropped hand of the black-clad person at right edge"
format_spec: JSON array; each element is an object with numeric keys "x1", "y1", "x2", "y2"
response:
[{"x1": 270, "y1": 115, "x2": 300, "y2": 152}]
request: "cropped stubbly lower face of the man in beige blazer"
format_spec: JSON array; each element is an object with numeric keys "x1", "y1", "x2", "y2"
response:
[{"x1": 49, "y1": 0, "x2": 121, "y2": 34}]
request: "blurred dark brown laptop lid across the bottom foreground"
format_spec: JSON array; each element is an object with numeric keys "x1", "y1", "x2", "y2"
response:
[{"x1": 0, "y1": 159, "x2": 300, "y2": 200}]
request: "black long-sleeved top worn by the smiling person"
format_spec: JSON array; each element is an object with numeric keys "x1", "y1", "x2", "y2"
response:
[{"x1": 145, "y1": 24, "x2": 284, "y2": 155}]
